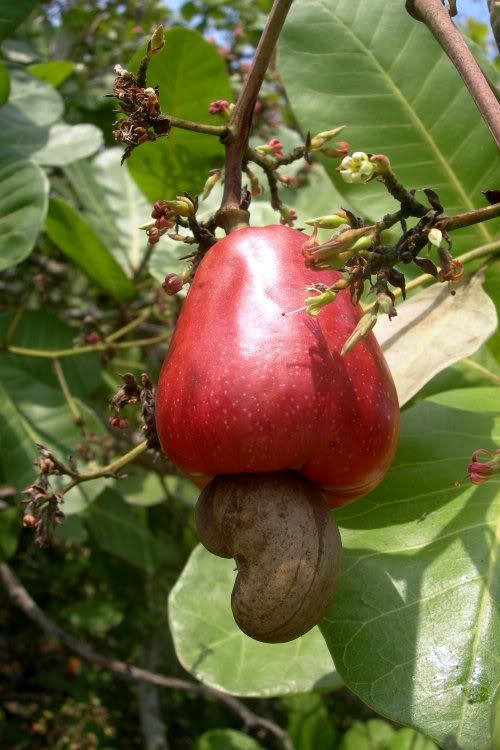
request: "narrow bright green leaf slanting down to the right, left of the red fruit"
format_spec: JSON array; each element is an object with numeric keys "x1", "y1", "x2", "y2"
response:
[{"x1": 45, "y1": 203, "x2": 135, "y2": 301}]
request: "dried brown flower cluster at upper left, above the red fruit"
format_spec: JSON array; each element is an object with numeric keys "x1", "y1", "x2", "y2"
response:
[{"x1": 113, "y1": 65, "x2": 170, "y2": 160}]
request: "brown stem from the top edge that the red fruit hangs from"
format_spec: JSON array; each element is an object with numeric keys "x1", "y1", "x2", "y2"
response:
[{"x1": 218, "y1": 0, "x2": 293, "y2": 234}]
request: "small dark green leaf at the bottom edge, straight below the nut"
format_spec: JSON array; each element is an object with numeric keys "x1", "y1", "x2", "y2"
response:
[{"x1": 281, "y1": 693, "x2": 337, "y2": 750}]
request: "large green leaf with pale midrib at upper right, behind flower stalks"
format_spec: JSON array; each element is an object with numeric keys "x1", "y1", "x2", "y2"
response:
[{"x1": 279, "y1": 0, "x2": 498, "y2": 252}]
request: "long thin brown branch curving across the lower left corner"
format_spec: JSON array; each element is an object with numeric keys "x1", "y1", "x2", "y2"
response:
[{"x1": 0, "y1": 563, "x2": 294, "y2": 750}]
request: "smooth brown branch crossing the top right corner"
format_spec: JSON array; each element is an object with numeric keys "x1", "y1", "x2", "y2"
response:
[{"x1": 406, "y1": 0, "x2": 500, "y2": 148}]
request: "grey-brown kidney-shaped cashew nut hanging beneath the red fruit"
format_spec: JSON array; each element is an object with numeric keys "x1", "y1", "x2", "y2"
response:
[{"x1": 196, "y1": 471, "x2": 341, "y2": 643}]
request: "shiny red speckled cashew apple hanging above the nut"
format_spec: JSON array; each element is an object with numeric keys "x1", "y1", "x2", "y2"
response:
[{"x1": 156, "y1": 226, "x2": 399, "y2": 507}]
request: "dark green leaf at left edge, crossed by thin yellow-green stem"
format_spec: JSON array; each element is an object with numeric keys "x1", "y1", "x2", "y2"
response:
[{"x1": 0, "y1": 310, "x2": 101, "y2": 396}]
